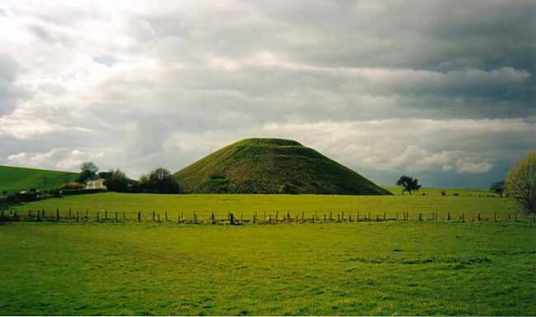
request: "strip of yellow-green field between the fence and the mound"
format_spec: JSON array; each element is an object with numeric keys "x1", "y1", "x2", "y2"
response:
[{"x1": 11, "y1": 192, "x2": 516, "y2": 219}]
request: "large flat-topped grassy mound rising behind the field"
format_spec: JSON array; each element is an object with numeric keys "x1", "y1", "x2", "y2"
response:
[{"x1": 175, "y1": 139, "x2": 390, "y2": 195}]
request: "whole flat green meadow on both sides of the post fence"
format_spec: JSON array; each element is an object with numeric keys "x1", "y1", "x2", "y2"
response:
[{"x1": 0, "y1": 188, "x2": 536, "y2": 315}]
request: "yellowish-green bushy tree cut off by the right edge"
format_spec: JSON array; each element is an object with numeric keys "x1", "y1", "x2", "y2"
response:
[{"x1": 506, "y1": 151, "x2": 536, "y2": 213}]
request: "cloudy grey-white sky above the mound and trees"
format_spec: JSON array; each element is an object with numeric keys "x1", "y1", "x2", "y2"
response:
[{"x1": 0, "y1": 0, "x2": 536, "y2": 187}]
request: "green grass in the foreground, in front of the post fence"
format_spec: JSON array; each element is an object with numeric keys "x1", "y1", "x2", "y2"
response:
[{"x1": 0, "y1": 223, "x2": 536, "y2": 315}]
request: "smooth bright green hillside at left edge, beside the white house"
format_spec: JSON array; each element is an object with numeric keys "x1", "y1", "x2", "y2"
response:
[{"x1": 0, "y1": 166, "x2": 78, "y2": 192}]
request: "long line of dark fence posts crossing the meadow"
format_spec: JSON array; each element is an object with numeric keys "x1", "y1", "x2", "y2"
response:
[{"x1": 0, "y1": 209, "x2": 536, "y2": 225}]
